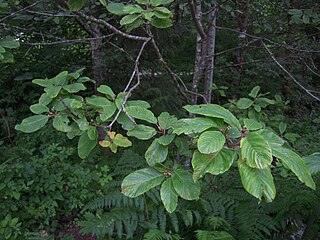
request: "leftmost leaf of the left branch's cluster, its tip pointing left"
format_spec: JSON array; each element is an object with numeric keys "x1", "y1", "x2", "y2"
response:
[{"x1": 15, "y1": 115, "x2": 49, "y2": 133}]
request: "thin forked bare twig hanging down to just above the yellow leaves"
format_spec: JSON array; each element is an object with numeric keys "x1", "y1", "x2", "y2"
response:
[{"x1": 105, "y1": 39, "x2": 150, "y2": 129}]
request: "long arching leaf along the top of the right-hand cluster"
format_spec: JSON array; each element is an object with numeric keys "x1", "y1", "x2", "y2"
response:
[{"x1": 183, "y1": 104, "x2": 241, "y2": 130}]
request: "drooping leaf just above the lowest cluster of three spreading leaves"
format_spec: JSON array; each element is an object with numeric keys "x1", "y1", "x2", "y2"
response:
[{"x1": 145, "y1": 139, "x2": 168, "y2": 166}]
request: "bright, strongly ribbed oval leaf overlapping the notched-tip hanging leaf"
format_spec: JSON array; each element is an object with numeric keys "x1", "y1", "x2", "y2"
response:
[{"x1": 240, "y1": 132, "x2": 272, "y2": 168}]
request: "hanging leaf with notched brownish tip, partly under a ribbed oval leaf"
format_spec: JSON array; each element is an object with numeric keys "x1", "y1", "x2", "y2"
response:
[{"x1": 238, "y1": 161, "x2": 276, "y2": 202}]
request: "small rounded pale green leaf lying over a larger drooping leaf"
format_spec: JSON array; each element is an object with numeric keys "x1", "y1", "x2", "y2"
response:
[{"x1": 197, "y1": 131, "x2": 226, "y2": 154}]
